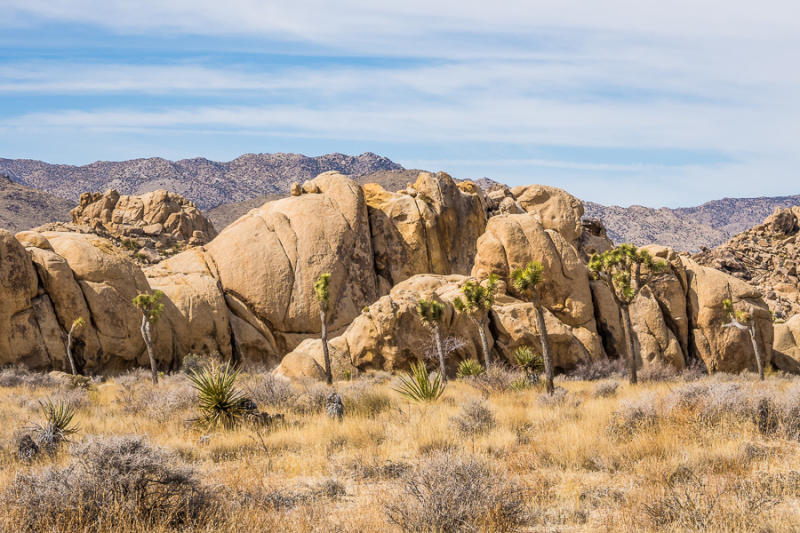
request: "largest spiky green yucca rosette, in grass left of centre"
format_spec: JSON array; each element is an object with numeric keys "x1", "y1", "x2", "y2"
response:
[{"x1": 189, "y1": 363, "x2": 245, "y2": 431}]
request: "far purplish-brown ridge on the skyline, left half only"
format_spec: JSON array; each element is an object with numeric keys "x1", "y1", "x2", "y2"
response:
[{"x1": 0, "y1": 152, "x2": 402, "y2": 210}]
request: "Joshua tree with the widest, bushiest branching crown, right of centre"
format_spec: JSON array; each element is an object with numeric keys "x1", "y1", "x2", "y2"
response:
[{"x1": 589, "y1": 244, "x2": 667, "y2": 385}]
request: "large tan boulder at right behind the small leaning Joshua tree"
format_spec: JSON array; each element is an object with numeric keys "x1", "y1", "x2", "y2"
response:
[{"x1": 681, "y1": 256, "x2": 773, "y2": 372}]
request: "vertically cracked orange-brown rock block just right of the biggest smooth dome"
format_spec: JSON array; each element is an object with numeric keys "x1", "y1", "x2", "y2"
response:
[{"x1": 364, "y1": 172, "x2": 486, "y2": 292}]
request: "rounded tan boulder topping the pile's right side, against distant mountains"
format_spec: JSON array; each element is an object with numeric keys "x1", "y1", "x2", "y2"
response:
[{"x1": 511, "y1": 185, "x2": 583, "y2": 244}]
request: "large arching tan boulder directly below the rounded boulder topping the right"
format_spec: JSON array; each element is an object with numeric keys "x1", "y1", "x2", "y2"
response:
[{"x1": 472, "y1": 215, "x2": 603, "y2": 360}]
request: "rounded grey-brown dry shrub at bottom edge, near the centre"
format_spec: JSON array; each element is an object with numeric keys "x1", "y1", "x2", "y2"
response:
[{"x1": 386, "y1": 453, "x2": 526, "y2": 533}]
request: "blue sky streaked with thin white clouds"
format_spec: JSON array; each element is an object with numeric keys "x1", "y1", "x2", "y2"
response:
[{"x1": 0, "y1": 0, "x2": 800, "y2": 207}]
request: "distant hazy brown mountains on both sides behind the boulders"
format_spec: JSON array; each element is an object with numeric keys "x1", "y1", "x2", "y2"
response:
[{"x1": 0, "y1": 152, "x2": 800, "y2": 252}]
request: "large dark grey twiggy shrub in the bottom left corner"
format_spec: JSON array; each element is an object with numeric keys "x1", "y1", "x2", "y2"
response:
[{"x1": 6, "y1": 436, "x2": 215, "y2": 531}]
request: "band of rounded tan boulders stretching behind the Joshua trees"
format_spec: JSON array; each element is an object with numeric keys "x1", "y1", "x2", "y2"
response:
[{"x1": 0, "y1": 172, "x2": 776, "y2": 378}]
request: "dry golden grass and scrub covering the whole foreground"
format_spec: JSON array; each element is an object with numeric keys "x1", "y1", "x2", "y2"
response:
[{"x1": 0, "y1": 370, "x2": 800, "y2": 533}]
